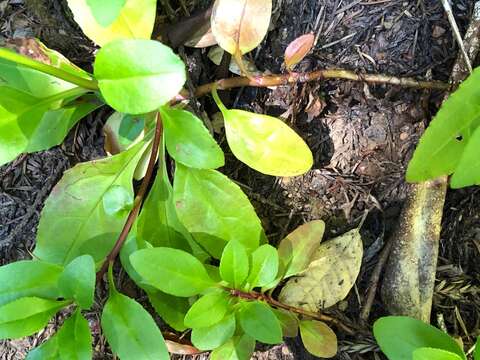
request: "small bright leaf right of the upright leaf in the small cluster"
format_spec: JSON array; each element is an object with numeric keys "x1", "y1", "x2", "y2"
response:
[{"x1": 247, "y1": 244, "x2": 278, "y2": 289}]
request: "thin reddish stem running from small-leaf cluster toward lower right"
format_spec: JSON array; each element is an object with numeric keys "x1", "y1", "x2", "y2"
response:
[{"x1": 229, "y1": 288, "x2": 354, "y2": 335}]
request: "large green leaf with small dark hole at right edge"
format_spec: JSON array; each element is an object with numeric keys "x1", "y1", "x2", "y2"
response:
[{"x1": 406, "y1": 68, "x2": 480, "y2": 182}]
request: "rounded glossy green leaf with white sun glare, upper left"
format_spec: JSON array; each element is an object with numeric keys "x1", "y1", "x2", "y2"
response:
[{"x1": 94, "y1": 40, "x2": 186, "y2": 115}]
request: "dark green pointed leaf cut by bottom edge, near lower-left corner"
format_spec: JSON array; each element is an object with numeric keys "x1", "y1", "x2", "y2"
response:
[{"x1": 56, "y1": 309, "x2": 92, "y2": 360}]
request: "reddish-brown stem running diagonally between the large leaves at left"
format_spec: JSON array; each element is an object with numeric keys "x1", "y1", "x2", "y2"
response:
[{"x1": 97, "y1": 112, "x2": 163, "y2": 282}]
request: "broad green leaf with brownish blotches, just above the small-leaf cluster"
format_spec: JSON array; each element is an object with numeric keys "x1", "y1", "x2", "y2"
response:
[{"x1": 173, "y1": 164, "x2": 263, "y2": 258}]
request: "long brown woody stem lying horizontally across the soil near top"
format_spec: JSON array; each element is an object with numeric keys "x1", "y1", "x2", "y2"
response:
[{"x1": 172, "y1": 69, "x2": 450, "y2": 102}]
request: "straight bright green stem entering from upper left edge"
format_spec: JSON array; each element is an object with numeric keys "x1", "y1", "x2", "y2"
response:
[{"x1": 0, "y1": 48, "x2": 98, "y2": 90}]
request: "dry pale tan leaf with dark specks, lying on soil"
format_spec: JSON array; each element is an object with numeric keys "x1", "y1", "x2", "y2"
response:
[{"x1": 279, "y1": 229, "x2": 363, "y2": 311}]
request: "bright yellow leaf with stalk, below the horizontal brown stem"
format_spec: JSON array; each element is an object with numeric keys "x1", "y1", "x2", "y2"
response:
[{"x1": 213, "y1": 91, "x2": 313, "y2": 176}]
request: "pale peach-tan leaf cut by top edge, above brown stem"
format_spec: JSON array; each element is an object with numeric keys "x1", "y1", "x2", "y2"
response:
[{"x1": 211, "y1": 0, "x2": 272, "y2": 55}]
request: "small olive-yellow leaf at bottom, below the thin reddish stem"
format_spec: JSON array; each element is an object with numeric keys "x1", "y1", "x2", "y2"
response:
[{"x1": 300, "y1": 320, "x2": 337, "y2": 358}]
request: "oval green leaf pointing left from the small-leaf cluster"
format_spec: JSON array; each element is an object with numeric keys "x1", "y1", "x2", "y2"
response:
[{"x1": 130, "y1": 247, "x2": 215, "y2": 297}]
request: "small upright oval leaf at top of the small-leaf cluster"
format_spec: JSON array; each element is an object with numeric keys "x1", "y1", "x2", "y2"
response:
[{"x1": 220, "y1": 240, "x2": 249, "y2": 289}]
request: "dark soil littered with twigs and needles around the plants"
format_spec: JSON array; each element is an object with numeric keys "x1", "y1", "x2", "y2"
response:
[{"x1": 0, "y1": 0, "x2": 480, "y2": 360}]
